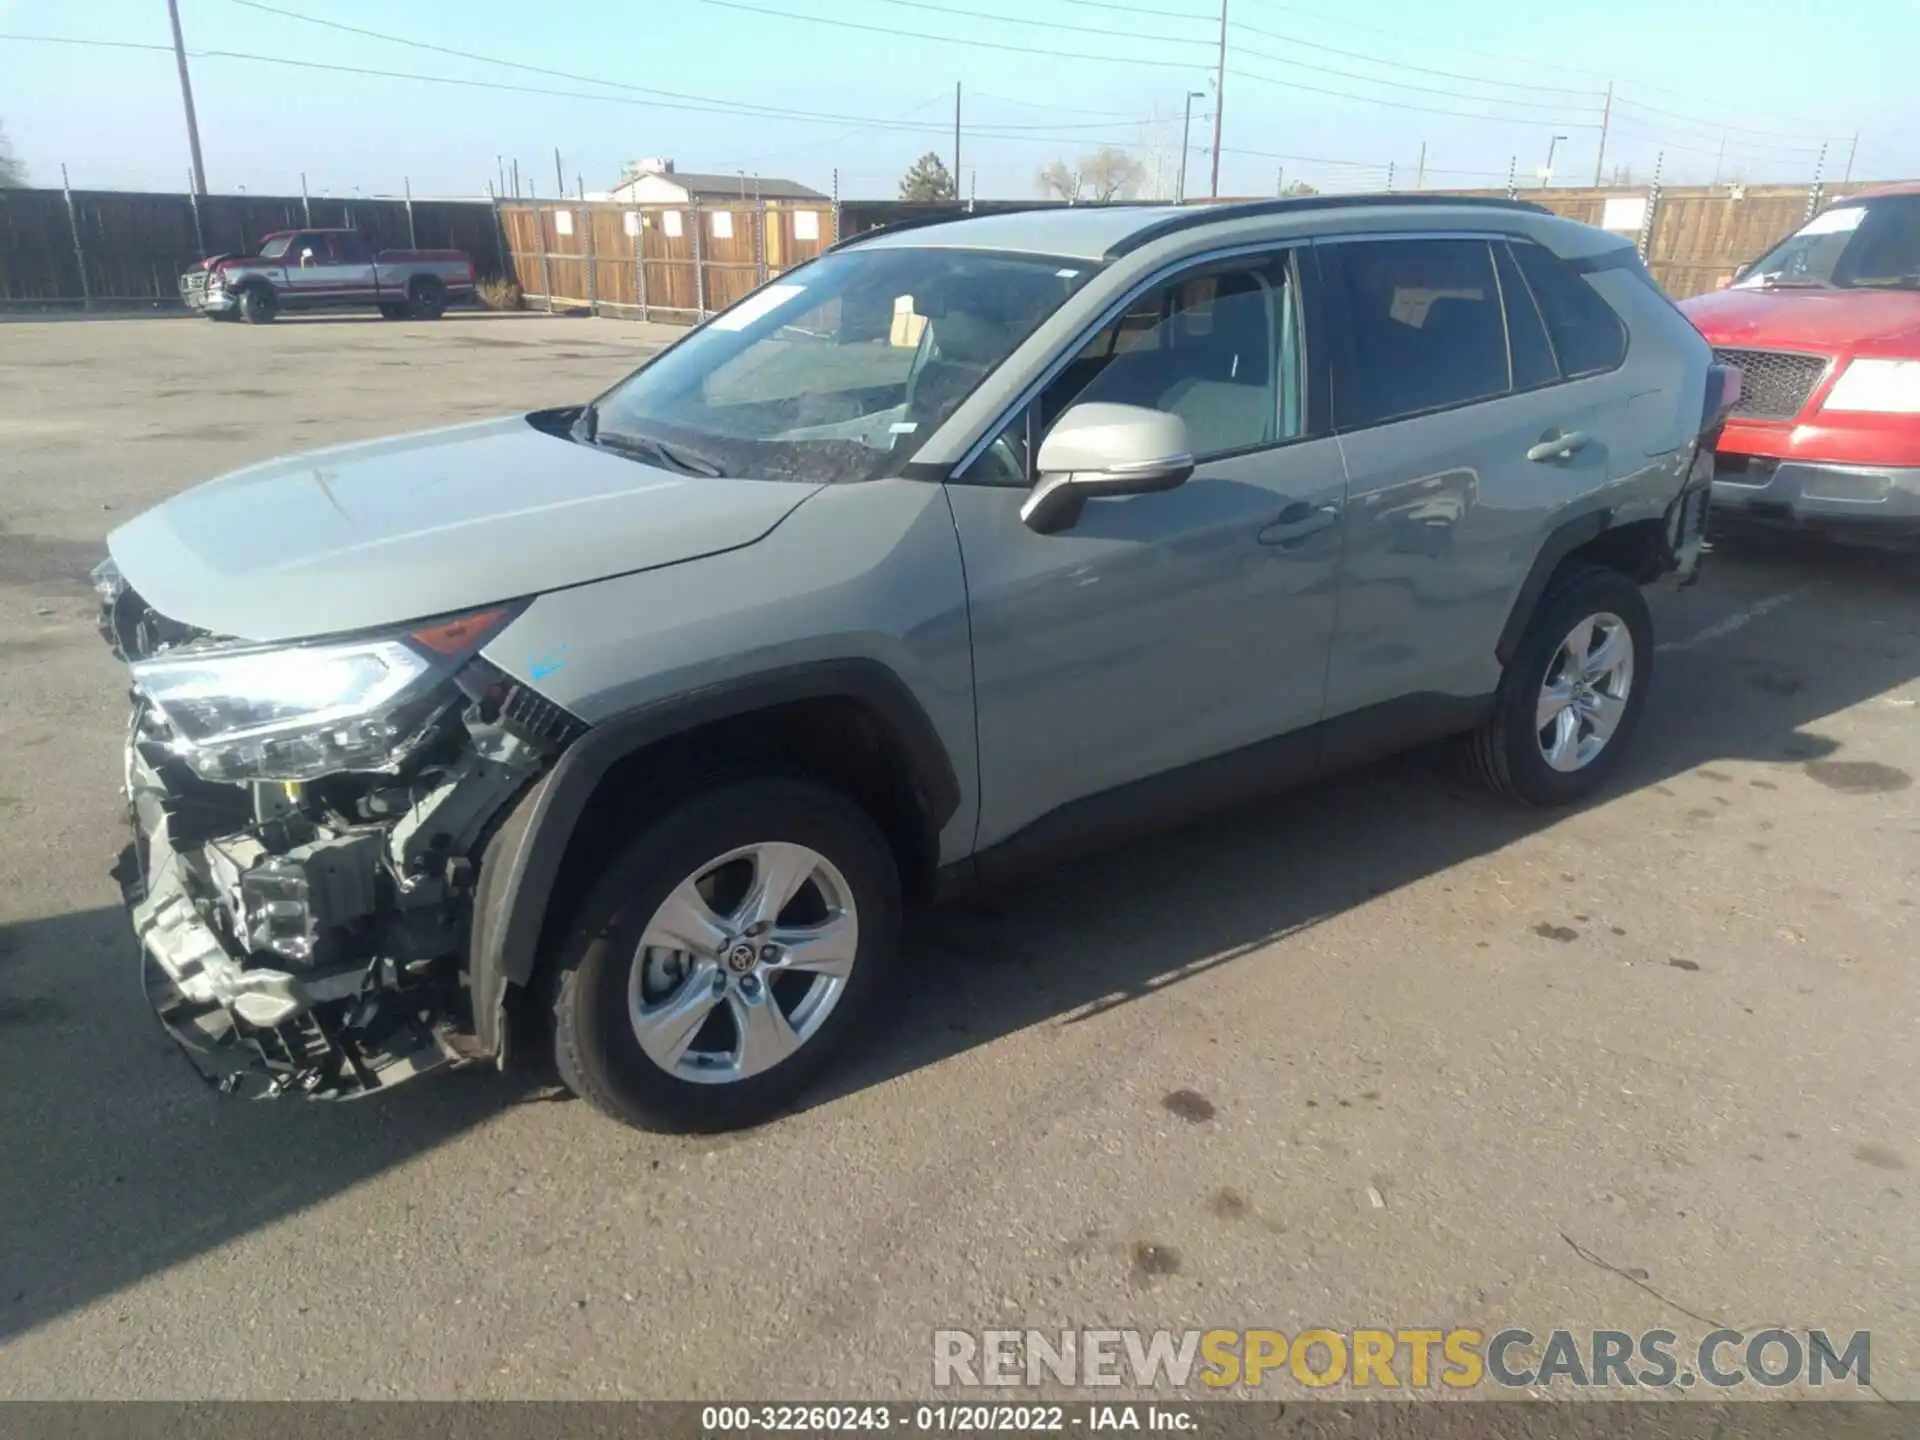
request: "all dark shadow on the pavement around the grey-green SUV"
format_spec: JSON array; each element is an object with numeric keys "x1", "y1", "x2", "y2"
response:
[{"x1": 0, "y1": 545, "x2": 1920, "y2": 1340}]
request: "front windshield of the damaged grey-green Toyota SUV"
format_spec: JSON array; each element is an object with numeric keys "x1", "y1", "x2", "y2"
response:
[{"x1": 589, "y1": 248, "x2": 1098, "y2": 482}]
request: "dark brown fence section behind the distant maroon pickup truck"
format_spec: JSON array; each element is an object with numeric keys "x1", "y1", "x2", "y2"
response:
[{"x1": 0, "y1": 190, "x2": 505, "y2": 307}]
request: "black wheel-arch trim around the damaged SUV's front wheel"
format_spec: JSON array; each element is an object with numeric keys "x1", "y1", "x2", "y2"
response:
[{"x1": 467, "y1": 659, "x2": 960, "y2": 1062}]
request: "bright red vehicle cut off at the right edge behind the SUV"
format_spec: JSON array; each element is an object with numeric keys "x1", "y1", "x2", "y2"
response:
[{"x1": 1680, "y1": 182, "x2": 1920, "y2": 534}]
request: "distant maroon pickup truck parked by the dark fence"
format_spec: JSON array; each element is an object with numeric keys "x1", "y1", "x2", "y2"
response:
[{"x1": 180, "y1": 230, "x2": 474, "y2": 324}]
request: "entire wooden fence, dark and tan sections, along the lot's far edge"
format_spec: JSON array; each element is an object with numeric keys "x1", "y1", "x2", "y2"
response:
[{"x1": 0, "y1": 182, "x2": 1889, "y2": 321}]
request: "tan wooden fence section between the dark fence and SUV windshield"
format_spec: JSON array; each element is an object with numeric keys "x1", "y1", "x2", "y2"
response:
[{"x1": 499, "y1": 200, "x2": 837, "y2": 321}]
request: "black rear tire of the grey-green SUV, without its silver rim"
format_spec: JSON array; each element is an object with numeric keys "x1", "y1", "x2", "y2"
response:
[{"x1": 1467, "y1": 566, "x2": 1653, "y2": 808}]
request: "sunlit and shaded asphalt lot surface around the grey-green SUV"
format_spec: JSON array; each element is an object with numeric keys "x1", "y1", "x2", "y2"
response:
[{"x1": 0, "y1": 315, "x2": 1920, "y2": 1400}]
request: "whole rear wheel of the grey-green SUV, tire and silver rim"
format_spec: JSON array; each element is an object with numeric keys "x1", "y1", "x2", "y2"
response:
[{"x1": 1471, "y1": 566, "x2": 1653, "y2": 806}]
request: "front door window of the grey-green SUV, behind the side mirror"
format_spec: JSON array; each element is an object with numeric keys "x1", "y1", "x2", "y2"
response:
[{"x1": 962, "y1": 257, "x2": 1306, "y2": 486}]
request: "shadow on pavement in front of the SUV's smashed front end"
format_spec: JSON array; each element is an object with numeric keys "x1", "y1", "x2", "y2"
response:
[{"x1": 0, "y1": 906, "x2": 540, "y2": 1340}]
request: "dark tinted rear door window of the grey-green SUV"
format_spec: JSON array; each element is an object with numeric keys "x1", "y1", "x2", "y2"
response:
[{"x1": 1323, "y1": 238, "x2": 1511, "y2": 430}]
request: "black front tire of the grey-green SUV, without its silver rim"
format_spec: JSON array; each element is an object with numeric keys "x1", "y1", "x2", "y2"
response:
[{"x1": 553, "y1": 780, "x2": 900, "y2": 1131}]
